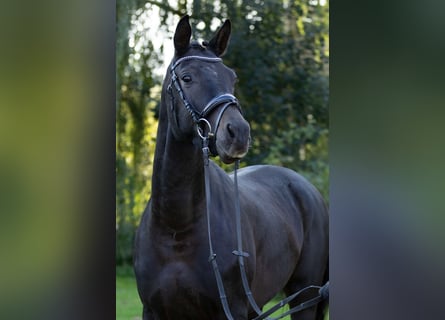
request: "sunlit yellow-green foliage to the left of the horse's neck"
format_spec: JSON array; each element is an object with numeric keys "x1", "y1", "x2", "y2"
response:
[{"x1": 116, "y1": 1, "x2": 159, "y2": 263}]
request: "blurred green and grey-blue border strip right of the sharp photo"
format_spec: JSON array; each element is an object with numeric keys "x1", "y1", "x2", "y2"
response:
[{"x1": 329, "y1": 1, "x2": 445, "y2": 320}]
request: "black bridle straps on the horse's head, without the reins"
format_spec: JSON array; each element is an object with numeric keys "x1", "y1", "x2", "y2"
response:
[{"x1": 167, "y1": 56, "x2": 242, "y2": 156}]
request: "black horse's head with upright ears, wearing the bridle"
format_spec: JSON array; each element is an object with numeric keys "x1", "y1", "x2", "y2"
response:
[{"x1": 163, "y1": 16, "x2": 250, "y2": 163}]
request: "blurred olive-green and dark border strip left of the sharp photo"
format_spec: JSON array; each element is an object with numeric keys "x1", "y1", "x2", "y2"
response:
[{"x1": 0, "y1": 0, "x2": 116, "y2": 319}]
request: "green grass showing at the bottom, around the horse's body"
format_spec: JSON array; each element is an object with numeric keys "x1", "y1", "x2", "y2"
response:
[{"x1": 116, "y1": 266, "x2": 329, "y2": 320}]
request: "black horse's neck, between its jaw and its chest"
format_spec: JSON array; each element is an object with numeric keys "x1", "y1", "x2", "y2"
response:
[{"x1": 151, "y1": 112, "x2": 205, "y2": 231}]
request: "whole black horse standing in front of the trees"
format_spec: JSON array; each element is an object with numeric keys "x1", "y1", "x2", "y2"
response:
[{"x1": 134, "y1": 16, "x2": 328, "y2": 320}]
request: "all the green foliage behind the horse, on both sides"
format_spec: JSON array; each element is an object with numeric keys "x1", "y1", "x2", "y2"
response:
[{"x1": 116, "y1": 0, "x2": 329, "y2": 263}]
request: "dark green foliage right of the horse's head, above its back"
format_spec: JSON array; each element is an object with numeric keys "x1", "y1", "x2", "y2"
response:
[{"x1": 220, "y1": 1, "x2": 329, "y2": 197}]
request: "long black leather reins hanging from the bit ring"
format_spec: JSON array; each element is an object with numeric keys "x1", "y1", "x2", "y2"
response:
[{"x1": 197, "y1": 128, "x2": 329, "y2": 320}]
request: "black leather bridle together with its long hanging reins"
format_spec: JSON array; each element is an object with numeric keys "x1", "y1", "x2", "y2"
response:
[{"x1": 167, "y1": 56, "x2": 329, "y2": 320}]
